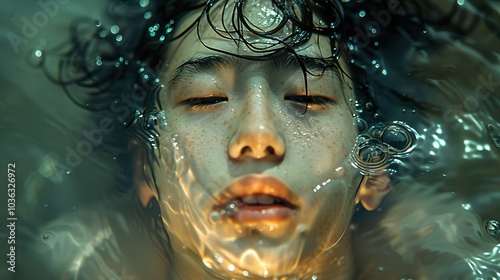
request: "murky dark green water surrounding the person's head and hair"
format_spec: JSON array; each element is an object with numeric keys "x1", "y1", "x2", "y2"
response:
[{"x1": 0, "y1": 0, "x2": 500, "y2": 279}]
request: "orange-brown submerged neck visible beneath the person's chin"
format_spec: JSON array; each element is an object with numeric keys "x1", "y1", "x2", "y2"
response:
[{"x1": 168, "y1": 233, "x2": 354, "y2": 280}]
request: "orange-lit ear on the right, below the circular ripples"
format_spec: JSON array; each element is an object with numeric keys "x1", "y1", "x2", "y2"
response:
[{"x1": 356, "y1": 174, "x2": 392, "y2": 211}]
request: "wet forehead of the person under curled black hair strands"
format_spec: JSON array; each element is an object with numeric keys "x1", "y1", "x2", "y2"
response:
[{"x1": 166, "y1": 0, "x2": 340, "y2": 64}]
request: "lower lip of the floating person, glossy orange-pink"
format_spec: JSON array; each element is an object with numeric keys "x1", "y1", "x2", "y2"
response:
[{"x1": 230, "y1": 205, "x2": 297, "y2": 223}]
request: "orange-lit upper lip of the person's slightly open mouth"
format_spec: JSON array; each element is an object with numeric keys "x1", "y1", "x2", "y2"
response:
[{"x1": 215, "y1": 175, "x2": 300, "y2": 209}]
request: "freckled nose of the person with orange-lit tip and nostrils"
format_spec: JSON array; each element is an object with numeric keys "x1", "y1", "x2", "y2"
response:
[{"x1": 229, "y1": 87, "x2": 285, "y2": 161}]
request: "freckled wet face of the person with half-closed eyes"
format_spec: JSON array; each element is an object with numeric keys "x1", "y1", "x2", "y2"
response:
[{"x1": 154, "y1": 1, "x2": 359, "y2": 276}]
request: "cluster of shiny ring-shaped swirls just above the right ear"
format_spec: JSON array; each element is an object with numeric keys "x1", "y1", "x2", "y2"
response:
[{"x1": 350, "y1": 118, "x2": 417, "y2": 175}]
